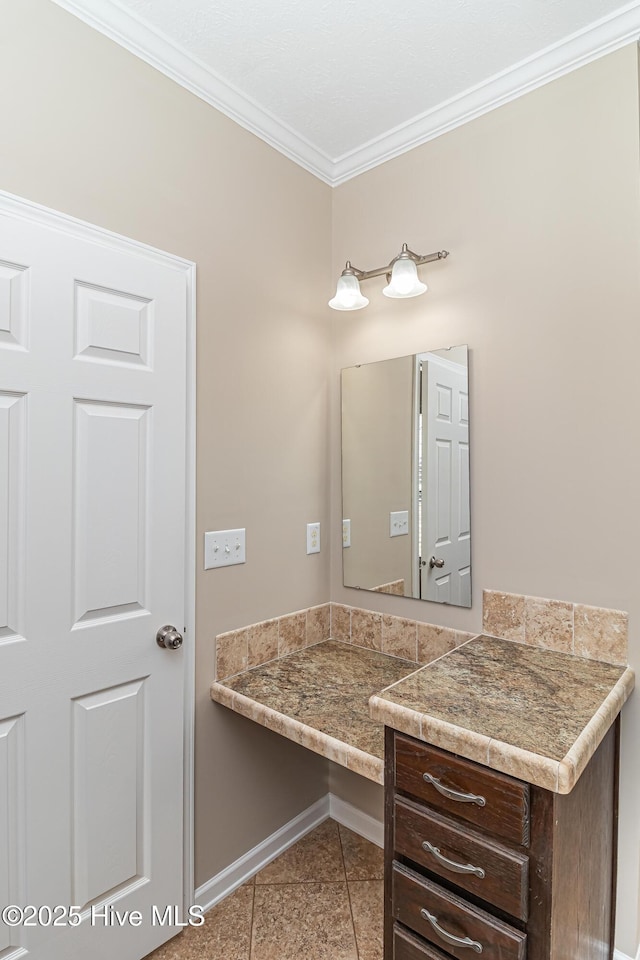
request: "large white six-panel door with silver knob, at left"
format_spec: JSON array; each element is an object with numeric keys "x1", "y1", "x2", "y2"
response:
[{"x1": 0, "y1": 199, "x2": 188, "y2": 960}]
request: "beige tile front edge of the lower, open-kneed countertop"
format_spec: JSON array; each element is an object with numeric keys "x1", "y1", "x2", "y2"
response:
[{"x1": 210, "y1": 682, "x2": 384, "y2": 783}]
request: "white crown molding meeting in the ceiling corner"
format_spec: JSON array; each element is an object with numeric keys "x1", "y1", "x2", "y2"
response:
[{"x1": 54, "y1": 0, "x2": 640, "y2": 186}]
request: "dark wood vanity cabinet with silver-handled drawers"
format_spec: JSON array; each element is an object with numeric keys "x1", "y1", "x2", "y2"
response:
[{"x1": 384, "y1": 721, "x2": 618, "y2": 960}]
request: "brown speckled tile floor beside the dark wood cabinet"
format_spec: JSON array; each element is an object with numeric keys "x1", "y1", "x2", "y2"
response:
[{"x1": 146, "y1": 820, "x2": 383, "y2": 960}]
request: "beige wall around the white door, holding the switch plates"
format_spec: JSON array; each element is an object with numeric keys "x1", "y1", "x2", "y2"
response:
[{"x1": 0, "y1": 0, "x2": 331, "y2": 884}]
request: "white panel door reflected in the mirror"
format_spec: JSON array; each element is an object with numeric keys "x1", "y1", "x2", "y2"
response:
[{"x1": 421, "y1": 357, "x2": 471, "y2": 606}]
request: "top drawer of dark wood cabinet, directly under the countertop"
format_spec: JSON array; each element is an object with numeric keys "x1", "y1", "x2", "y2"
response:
[{"x1": 394, "y1": 734, "x2": 529, "y2": 846}]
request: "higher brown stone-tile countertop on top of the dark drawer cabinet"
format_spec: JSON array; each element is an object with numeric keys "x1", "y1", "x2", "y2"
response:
[{"x1": 369, "y1": 636, "x2": 634, "y2": 793}]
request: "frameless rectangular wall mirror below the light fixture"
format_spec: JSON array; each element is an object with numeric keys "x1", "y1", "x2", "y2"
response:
[{"x1": 342, "y1": 346, "x2": 471, "y2": 607}]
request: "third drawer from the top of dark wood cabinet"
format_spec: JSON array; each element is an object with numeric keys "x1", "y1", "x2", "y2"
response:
[{"x1": 392, "y1": 863, "x2": 527, "y2": 960}]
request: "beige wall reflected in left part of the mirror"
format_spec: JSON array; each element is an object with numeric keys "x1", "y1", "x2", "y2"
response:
[{"x1": 341, "y1": 357, "x2": 414, "y2": 592}]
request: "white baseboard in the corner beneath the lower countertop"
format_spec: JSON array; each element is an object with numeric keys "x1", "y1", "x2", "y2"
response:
[{"x1": 195, "y1": 793, "x2": 384, "y2": 912}]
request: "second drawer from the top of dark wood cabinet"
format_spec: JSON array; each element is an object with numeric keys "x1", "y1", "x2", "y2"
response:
[{"x1": 394, "y1": 798, "x2": 529, "y2": 920}]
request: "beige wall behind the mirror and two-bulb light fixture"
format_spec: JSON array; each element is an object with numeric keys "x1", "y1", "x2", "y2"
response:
[{"x1": 331, "y1": 45, "x2": 640, "y2": 955}]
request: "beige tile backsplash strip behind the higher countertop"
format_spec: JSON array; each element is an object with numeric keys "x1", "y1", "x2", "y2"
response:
[{"x1": 482, "y1": 590, "x2": 629, "y2": 666}]
